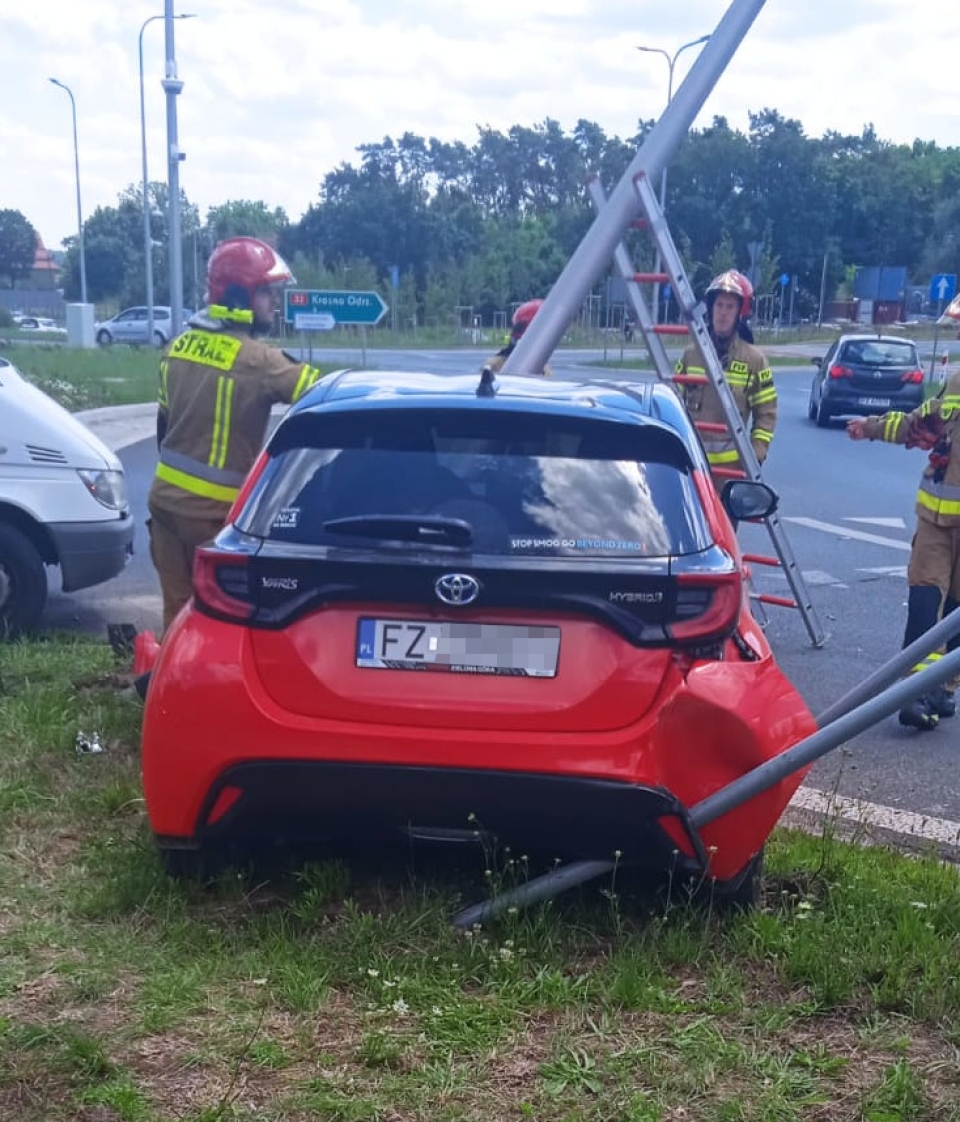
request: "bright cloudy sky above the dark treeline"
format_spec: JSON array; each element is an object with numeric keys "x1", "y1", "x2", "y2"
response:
[{"x1": 7, "y1": 0, "x2": 960, "y2": 248}]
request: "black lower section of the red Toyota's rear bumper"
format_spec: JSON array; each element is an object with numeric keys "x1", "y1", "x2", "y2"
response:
[{"x1": 157, "y1": 761, "x2": 704, "y2": 873}]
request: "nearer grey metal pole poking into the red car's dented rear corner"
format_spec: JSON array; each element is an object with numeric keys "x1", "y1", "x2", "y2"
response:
[{"x1": 690, "y1": 646, "x2": 960, "y2": 829}]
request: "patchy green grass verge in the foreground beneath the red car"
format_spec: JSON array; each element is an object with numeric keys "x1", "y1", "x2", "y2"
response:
[{"x1": 0, "y1": 635, "x2": 960, "y2": 1122}]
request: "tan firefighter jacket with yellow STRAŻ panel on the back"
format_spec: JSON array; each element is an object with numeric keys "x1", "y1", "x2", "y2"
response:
[{"x1": 150, "y1": 316, "x2": 321, "y2": 521}]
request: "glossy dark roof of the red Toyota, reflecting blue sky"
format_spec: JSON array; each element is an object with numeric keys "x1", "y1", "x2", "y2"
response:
[{"x1": 281, "y1": 369, "x2": 693, "y2": 438}]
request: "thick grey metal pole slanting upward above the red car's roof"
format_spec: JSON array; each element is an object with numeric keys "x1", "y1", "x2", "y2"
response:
[{"x1": 502, "y1": 0, "x2": 764, "y2": 374}]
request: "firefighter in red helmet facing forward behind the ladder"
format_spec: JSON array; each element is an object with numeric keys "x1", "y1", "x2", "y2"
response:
[{"x1": 676, "y1": 269, "x2": 777, "y2": 481}]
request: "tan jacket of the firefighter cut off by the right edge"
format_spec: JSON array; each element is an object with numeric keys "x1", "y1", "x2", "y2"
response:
[{"x1": 865, "y1": 374, "x2": 960, "y2": 527}]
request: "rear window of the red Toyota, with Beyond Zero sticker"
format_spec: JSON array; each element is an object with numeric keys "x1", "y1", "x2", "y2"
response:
[{"x1": 237, "y1": 410, "x2": 711, "y2": 558}]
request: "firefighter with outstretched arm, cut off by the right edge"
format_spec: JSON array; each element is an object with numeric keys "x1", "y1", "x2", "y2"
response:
[{"x1": 847, "y1": 373, "x2": 960, "y2": 732}]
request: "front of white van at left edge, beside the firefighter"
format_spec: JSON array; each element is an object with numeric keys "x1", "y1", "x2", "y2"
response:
[{"x1": 0, "y1": 358, "x2": 133, "y2": 638}]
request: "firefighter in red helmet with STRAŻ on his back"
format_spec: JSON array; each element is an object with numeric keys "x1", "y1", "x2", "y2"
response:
[{"x1": 147, "y1": 238, "x2": 321, "y2": 631}]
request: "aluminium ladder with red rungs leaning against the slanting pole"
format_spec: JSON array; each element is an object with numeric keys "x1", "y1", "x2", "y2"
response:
[{"x1": 588, "y1": 172, "x2": 828, "y2": 647}]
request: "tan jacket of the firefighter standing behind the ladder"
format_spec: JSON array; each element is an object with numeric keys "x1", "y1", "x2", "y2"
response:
[{"x1": 676, "y1": 335, "x2": 777, "y2": 469}]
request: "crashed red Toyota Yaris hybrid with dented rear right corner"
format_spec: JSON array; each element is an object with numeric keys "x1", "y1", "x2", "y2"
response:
[{"x1": 142, "y1": 371, "x2": 815, "y2": 893}]
